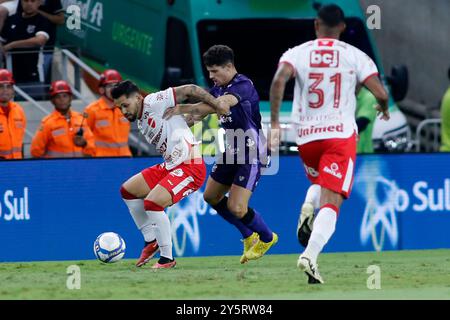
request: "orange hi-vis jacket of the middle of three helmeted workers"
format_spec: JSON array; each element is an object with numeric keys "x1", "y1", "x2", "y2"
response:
[{"x1": 31, "y1": 110, "x2": 95, "y2": 158}]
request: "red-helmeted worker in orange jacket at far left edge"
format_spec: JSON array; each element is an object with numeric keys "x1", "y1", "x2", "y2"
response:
[{"x1": 0, "y1": 69, "x2": 27, "y2": 159}]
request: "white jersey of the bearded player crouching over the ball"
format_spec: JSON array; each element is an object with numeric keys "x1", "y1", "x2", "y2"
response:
[{"x1": 137, "y1": 88, "x2": 198, "y2": 170}]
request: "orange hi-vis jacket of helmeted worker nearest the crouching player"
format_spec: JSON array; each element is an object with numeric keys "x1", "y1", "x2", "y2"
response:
[{"x1": 85, "y1": 97, "x2": 131, "y2": 157}]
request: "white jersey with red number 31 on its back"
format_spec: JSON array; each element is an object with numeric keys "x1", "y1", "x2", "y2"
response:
[{"x1": 280, "y1": 38, "x2": 378, "y2": 145}]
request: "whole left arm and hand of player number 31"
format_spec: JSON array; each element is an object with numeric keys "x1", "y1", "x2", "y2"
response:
[{"x1": 269, "y1": 63, "x2": 295, "y2": 151}]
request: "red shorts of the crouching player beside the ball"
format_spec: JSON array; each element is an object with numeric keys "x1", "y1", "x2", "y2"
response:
[{"x1": 141, "y1": 159, "x2": 206, "y2": 204}]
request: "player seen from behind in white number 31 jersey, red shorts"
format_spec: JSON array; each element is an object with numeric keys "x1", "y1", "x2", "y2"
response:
[{"x1": 270, "y1": 5, "x2": 389, "y2": 283}]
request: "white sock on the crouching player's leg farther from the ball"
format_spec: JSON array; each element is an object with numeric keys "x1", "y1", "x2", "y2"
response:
[{"x1": 146, "y1": 211, "x2": 173, "y2": 260}]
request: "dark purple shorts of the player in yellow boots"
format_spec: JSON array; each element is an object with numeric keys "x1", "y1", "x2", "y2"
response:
[{"x1": 210, "y1": 163, "x2": 261, "y2": 192}]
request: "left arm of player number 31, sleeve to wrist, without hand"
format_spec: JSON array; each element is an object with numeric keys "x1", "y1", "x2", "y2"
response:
[{"x1": 270, "y1": 63, "x2": 295, "y2": 128}]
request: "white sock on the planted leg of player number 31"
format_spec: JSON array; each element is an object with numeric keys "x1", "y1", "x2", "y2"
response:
[{"x1": 303, "y1": 207, "x2": 337, "y2": 263}]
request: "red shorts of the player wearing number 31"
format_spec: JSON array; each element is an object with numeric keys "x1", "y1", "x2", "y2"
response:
[{"x1": 298, "y1": 134, "x2": 356, "y2": 198}]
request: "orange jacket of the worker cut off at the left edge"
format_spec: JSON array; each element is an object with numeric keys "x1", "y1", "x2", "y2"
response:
[{"x1": 0, "y1": 101, "x2": 27, "y2": 159}]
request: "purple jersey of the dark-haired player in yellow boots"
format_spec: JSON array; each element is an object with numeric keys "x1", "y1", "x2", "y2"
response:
[{"x1": 210, "y1": 74, "x2": 266, "y2": 163}]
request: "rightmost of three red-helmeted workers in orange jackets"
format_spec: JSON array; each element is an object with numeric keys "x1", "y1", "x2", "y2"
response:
[{"x1": 85, "y1": 69, "x2": 131, "y2": 157}]
